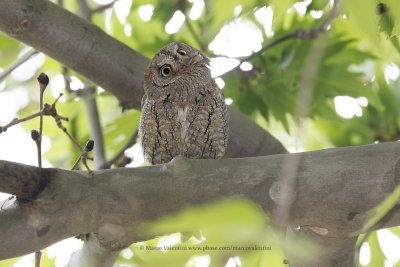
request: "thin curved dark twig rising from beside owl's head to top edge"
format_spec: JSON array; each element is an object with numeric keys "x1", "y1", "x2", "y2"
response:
[{"x1": 218, "y1": 0, "x2": 341, "y2": 78}]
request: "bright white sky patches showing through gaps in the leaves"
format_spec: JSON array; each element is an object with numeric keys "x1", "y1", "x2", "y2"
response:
[{"x1": 0, "y1": 0, "x2": 400, "y2": 267}]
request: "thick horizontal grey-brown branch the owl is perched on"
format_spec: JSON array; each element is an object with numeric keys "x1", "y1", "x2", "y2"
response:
[{"x1": 0, "y1": 142, "x2": 400, "y2": 266}]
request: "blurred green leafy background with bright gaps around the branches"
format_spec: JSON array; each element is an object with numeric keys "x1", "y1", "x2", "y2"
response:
[{"x1": 0, "y1": 0, "x2": 400, "y2": 266}]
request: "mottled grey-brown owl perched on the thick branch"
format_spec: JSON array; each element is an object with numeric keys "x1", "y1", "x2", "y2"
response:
[{"x1": 139, "y1": 43, "x2": 228, "y2": 164}]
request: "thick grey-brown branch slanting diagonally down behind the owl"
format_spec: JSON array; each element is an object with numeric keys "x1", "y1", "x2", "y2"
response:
[{"x1": 0, "y1": 0, "x2": 286, "y2": 157}]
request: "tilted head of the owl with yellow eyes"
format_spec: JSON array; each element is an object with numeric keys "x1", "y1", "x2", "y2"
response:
[{"x1": 144, "y1": 43, "x2": 211, "y2": 93}]
